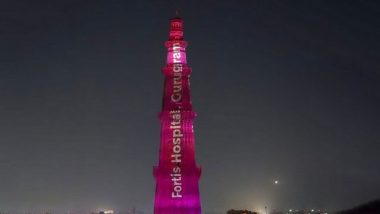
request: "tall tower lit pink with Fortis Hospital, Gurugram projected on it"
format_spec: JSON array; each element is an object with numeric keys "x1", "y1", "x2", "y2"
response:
[{"x1": 154, "y1": 17, "x2": 201, "y2": 214}]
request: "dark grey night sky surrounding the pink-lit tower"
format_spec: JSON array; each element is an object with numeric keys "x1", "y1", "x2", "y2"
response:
[{"x1": 0, "y1": 0, "x2": 380, "y2": 213}]
